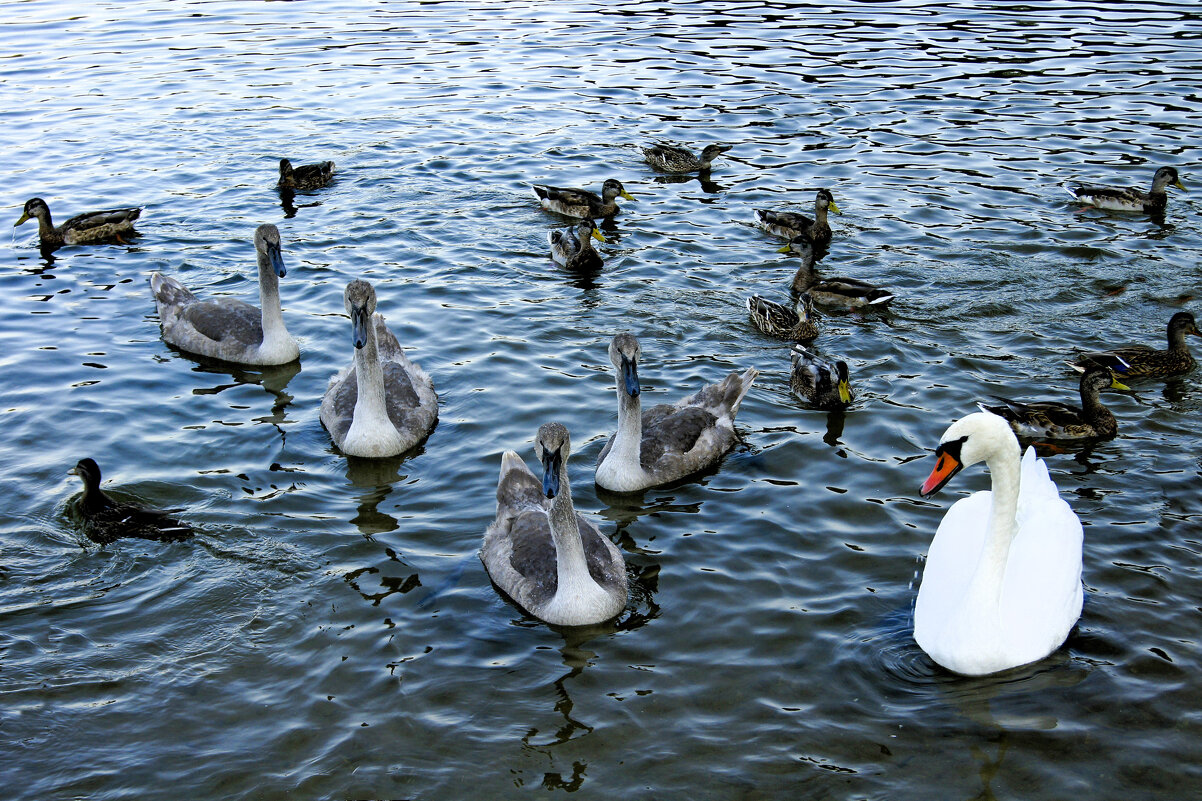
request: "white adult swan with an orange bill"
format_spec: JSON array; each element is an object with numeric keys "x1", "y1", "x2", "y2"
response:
[{"x1": 914, "y1": 411, "x2": 1082, "y2": 676}]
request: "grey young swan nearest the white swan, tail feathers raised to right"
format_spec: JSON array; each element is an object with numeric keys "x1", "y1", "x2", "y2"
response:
[{"x1": 596, "y1": 332, "x2": 760, "y2": 492}]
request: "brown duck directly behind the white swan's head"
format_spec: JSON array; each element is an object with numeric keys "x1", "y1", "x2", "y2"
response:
[{"x1": 977, "y1": 366, "x2": 1131, "y2": 439}]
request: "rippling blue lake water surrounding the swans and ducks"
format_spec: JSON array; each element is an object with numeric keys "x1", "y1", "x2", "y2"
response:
[{"x1": 0, "y1": 0, "x2": 1202, "y2": 800}]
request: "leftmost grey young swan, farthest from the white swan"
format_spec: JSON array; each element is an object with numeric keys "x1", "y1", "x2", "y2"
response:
[{"x1": 150, "y1": 223, "x2": 301, "y2": 366}]
